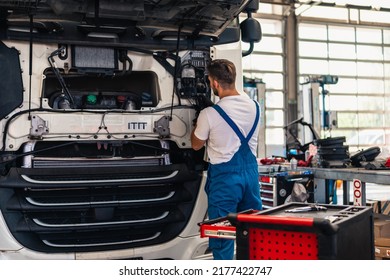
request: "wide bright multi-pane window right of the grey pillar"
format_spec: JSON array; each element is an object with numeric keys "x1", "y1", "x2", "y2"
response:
[{"x1": 298, "y1": 22, "x2": 390, "y2": 151}]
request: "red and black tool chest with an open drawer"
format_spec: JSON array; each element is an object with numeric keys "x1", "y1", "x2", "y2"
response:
[{"x1": 201, "y1": 203, "x2": 374, "y2": 260}]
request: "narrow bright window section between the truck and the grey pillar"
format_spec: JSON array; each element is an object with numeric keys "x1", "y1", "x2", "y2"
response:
[{"x1": 242, "y1": 17, "x2": 286, "y2": 157}]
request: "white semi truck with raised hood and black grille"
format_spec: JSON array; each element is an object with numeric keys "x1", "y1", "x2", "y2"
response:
[{"x1": 0, "y1": 0, "x2": 261, "y2": 259}]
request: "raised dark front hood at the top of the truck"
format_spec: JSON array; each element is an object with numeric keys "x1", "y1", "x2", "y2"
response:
[{"x1": 0, "y1": 0, "x2": 250, "y2": 47}]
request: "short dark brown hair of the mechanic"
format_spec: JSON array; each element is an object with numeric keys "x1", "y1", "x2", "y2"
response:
[{"x1": 207, "y1": 59, "x2": 236, "y2": 88}]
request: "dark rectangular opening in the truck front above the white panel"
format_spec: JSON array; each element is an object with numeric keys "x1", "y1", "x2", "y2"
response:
[{"x1": 43, "y1": 69, "x2": 160, "y2": 110}]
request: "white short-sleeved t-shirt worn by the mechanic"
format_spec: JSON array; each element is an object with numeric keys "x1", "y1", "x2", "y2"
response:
[{"x1": 195, "y1": 94, "x2": 260, "y2": 164}]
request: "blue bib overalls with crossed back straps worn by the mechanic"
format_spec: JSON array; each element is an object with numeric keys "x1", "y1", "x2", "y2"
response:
[{"x1": 205, "y1": 102, "x2": 262, "y2": 260}]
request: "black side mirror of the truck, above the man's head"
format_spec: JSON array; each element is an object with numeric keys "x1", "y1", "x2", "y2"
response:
[{"x1": 240, "y1": 0, "x2": 262, "y2": 56}]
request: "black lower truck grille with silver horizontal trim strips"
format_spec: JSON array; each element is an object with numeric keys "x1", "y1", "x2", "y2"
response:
[{"x1": 0, "y1": 164, "x2": 200, "y2": 253}]
